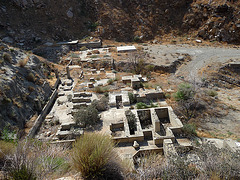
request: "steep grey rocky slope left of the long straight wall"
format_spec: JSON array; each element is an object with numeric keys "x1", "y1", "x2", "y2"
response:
[{"x1": 0, "y1": 43, "x2": 52, "y2": 130}]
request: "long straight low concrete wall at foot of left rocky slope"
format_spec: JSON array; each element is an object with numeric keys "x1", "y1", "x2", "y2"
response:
[{"x1": 27, "y1": 89, "x2": 58, "y2": 138}]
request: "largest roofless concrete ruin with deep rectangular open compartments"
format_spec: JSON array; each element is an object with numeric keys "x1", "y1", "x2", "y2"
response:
[{"x1": 110, "y1": 106, "x2": 183, "y2": 156}]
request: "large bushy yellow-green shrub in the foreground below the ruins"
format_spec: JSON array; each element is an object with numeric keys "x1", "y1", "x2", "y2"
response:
[{"x1": 71, "y1": 133, "x2": 114, "y2": 179}]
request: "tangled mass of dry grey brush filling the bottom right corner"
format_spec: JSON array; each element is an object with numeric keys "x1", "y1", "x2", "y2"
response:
[{"x1": 126, "y1": 144, "x2": 240, "y2": 180}]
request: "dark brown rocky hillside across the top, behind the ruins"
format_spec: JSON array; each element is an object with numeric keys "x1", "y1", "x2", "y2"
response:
[{"x1": 0, "y1": 0, "x2": 240, "y2": 49}]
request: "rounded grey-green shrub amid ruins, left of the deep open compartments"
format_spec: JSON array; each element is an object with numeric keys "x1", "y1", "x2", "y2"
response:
[{"x1": 74, "y1": 105, "x2": 99, "y2": 127}]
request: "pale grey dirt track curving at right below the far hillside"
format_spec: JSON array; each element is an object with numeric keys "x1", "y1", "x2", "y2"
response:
[{"x1": 147, "y1": 45, "x2": 240, "y2": 82}]
